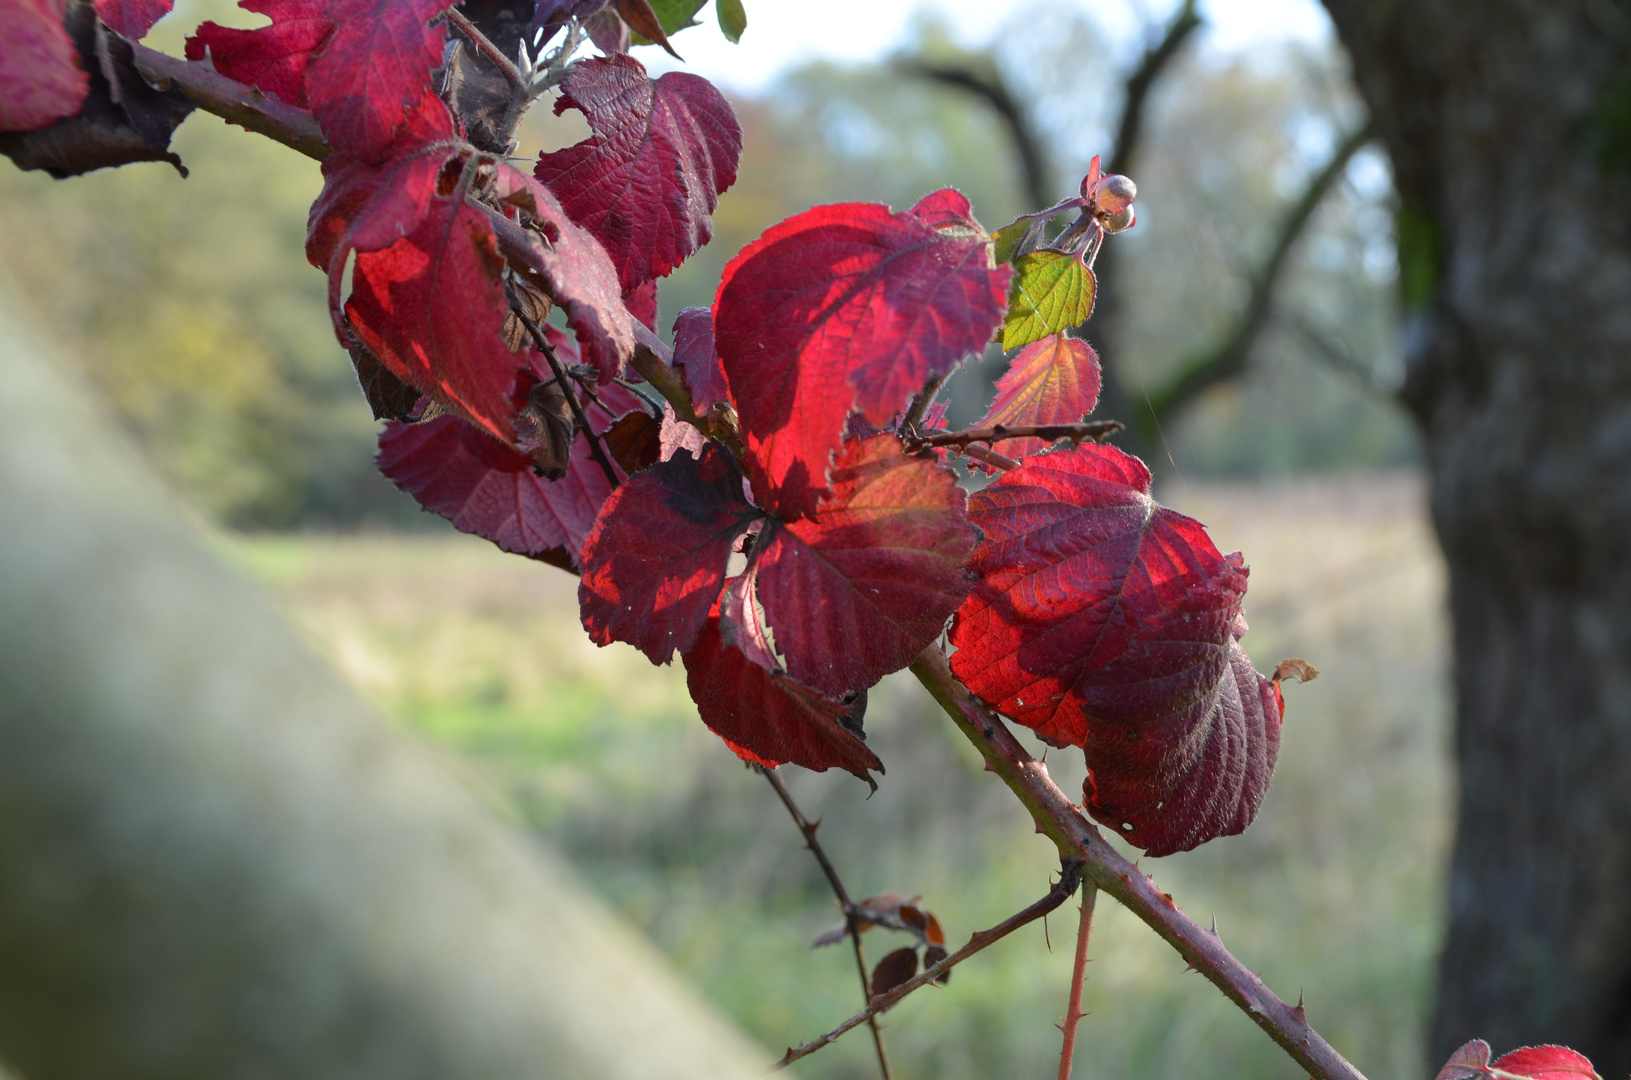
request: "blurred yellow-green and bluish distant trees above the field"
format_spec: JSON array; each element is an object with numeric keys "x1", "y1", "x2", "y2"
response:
[{"x1": 0, "y1": 0, "x2": 1416, "y2": 529}]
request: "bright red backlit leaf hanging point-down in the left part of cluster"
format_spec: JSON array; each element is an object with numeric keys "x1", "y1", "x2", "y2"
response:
[{"x1": 346, "y1": 197, "x2": 527, "y2": 442}]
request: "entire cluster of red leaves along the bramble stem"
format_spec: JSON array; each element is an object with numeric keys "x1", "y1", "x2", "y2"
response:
[{"x1": 0, "y1": 0, "x2": 1282, "y2": 853}]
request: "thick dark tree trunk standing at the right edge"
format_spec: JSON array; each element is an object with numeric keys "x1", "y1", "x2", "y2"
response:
[{"x1": 1324, "y1": 0, "x2": 1631, "y2": 1077}]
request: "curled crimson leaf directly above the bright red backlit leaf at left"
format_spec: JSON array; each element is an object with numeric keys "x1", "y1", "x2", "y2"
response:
[{"x1": 307, "y1": 90, "x2": 457, "y2": 301}]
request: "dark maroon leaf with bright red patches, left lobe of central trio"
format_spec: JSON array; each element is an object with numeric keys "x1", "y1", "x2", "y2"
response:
[{"x1": 577, "y1": 445, "x2": 758, "y2": 664}]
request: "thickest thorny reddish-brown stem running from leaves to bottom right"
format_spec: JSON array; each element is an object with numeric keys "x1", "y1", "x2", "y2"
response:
[{"x1": 912, "y1": 646, "x2": 1364, "y2": 1080}]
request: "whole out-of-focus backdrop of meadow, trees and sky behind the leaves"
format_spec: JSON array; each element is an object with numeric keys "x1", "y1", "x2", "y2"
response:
[{"x1": 0, "y1": 0, "x2": 1450, "y2": 1080}]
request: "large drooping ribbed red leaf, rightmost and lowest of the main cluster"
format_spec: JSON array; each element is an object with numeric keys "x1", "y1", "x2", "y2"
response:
[{"x1": 951, "y1": 445, "x2": 1280, "y2": 855}]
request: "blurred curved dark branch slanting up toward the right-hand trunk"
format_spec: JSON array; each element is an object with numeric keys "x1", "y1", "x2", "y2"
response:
[{"x1": 1150, "y1": 124, "x2": 1372, "y2": 421}]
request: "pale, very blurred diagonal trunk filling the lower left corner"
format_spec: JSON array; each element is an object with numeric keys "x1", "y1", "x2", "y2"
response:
[{"x1": 0, "y1": 297, "x2": 770, "y2": 1080}]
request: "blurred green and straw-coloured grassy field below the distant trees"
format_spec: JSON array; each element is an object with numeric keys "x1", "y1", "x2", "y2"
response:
[{"x1": 223, "y1": 476, "x2": 1450, "y2": 1080}]
